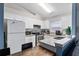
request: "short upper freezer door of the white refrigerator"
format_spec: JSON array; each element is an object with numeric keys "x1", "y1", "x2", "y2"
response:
[{"x1": 7, "y1": 20, "x2": 25, "y2": 33}]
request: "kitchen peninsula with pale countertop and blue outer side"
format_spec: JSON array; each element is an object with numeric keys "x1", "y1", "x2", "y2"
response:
[{"x1": 40, "y1": 35, "x2": 75, "y2": 56}]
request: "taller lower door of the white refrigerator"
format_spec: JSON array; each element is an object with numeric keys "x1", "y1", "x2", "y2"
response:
[{"x1": 7, "y1": 33, "x2": 25, "y2": 54}]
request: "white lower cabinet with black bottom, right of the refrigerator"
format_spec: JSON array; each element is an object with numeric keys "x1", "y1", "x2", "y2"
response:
[{"x1": 22, "y1": 35, "x2": 35, "y2": 50}]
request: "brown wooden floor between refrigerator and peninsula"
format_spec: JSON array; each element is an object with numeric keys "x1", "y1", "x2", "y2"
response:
[{"x1": 11, "y1": 47, "x2": 55, "y2": 56}]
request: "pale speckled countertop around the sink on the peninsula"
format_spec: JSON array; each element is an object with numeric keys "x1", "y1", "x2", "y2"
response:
[{"x1": 43, "y1": 35, "x2": 75, "y2": 47}]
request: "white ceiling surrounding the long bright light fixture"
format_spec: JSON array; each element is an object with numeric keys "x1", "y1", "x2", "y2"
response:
[{"x1": 4, "y1": 3, "x2": 72, "y2": 18}]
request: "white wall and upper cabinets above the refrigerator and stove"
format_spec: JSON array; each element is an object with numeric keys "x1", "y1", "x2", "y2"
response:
[{"x1": 4, "y1": 7, "x2": 43, "y2": 28}]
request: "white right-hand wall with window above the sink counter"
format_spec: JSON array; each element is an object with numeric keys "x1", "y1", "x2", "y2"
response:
[{"x1": 46, "y1": 14, "x2": 72, "y2": 32}]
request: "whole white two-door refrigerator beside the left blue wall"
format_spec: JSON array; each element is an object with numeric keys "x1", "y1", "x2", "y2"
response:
[{"x1": 7, "y1": 20, "x2": 25, "y2": 54}]
